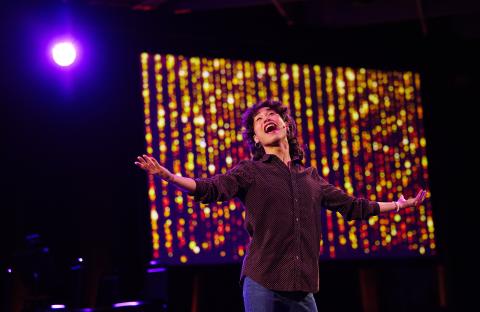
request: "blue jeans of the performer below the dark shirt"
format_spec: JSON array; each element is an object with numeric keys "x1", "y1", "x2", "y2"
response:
[{"x1": 243, "y1": 276, "x2": 317, "y2": 312}]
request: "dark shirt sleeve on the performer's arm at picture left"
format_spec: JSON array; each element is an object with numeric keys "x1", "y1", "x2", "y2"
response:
[{"x1": 188, "y1": 160, "x2": 254, "y2": 204}]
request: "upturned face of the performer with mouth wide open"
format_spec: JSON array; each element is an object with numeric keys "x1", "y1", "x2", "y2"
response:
[{"x1": 253, "y1": 107, "x2": 287, "y2": 146}]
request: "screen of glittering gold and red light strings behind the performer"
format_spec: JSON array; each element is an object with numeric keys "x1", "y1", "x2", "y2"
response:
[{"x1": 141, "y1": 53, "x2": 436, "y2": 264}]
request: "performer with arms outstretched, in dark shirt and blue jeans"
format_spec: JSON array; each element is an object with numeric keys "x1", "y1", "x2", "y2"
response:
[{"x1": 135, "y1": 100, "x2": 426, "y2": 312}]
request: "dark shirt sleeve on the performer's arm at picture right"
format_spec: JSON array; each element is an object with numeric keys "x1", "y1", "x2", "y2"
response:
[{"x1": 315, "y1": 170, "x2": 380, "y2": 220}]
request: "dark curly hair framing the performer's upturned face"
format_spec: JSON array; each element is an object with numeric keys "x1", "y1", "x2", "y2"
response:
[{"x1": 242, "y1": 99, "x2": 304, "y2": 162}]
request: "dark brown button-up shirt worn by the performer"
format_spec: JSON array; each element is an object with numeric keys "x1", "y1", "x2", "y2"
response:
[{"x1": 190, "y1": 154, "x2": 380, "y2": 292}]
